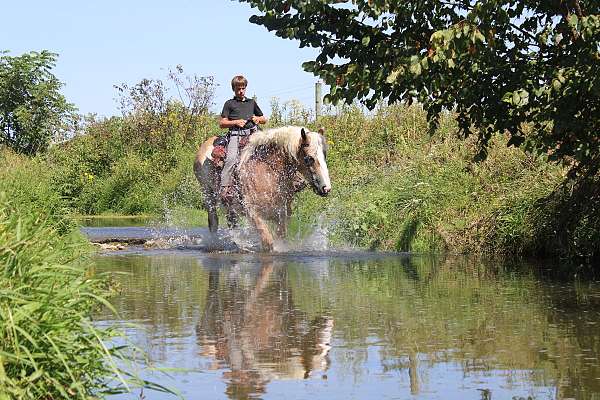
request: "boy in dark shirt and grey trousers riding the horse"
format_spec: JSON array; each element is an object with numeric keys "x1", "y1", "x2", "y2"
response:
[{"x1": 219, "y1": 75, "x2": 267, "y2": 200}]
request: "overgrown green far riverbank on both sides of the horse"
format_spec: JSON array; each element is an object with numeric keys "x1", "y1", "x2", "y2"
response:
[{"x1": 5, "y1": 105, "x2": 600, "y2": 263}]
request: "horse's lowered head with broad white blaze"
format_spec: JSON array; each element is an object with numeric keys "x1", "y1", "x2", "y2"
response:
[{"x1": 299, "y1": 128, "x2": 331, "y2": 196}]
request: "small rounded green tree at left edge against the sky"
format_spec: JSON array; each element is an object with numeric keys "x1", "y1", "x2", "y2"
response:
[{"x1": 0, "y1": 50, "x2": 75, "y2": 155}]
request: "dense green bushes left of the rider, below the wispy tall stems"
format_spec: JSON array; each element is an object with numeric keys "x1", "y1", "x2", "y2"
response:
[{"x1": 46, "y1": 101, "x2": 220, "y2": 214}]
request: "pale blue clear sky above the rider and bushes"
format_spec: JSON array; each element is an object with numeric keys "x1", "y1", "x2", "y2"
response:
[{"x1": 0, "y1": 0, "x2": 317, "y2": 116}]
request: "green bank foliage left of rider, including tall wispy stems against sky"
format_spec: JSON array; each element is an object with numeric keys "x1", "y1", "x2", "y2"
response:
[{"x1": 47, "y1": 67, "x2": 219, "y2": 219}]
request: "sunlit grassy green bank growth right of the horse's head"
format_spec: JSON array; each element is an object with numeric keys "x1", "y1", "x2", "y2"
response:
[{"x1": 297, "y1": 105, "x2": 564, "y2": 255}]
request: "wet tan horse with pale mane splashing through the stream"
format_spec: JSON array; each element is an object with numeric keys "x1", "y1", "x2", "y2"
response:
[{"x1": 194, "y1": 126, "x2": 331, "y2": 251}]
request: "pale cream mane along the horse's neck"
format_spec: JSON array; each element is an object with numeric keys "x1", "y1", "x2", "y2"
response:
[{"x1": 239, "y1": 126, "x2": 309, "y2": 165}]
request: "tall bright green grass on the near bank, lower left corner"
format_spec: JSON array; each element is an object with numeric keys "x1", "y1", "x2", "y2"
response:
[{"x1": 0, "y1": 152, "x2": 168, "y2": 400}]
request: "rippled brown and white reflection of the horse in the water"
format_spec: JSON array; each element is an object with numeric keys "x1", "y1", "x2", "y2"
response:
[{"x1": 197, "y1": 261, "x2": 333, "y2": 399}]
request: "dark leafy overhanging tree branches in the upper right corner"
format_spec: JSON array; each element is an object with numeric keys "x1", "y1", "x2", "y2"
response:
[{"x1": 239, "y1": 0, "x2": 600, "y2": 173}]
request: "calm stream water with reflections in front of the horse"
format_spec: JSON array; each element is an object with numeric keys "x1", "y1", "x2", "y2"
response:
[{"x1": 88, "y1": 227, "x2": 600, "y2": 399}]
